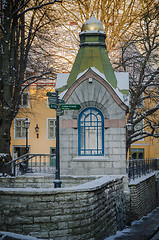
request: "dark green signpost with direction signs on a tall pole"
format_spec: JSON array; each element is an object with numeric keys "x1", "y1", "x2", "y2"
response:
[{"x1": 46, "y1": 90, "x2": 81, "y2": 188}]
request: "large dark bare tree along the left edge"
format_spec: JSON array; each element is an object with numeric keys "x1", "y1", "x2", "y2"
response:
[{"x1": 0, "y1": 0, "x2": 62, "y2": 163}]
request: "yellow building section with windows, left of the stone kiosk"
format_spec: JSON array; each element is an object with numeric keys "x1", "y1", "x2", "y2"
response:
[{"x1": 10, "y1": 84, "x2": 56, "y2": 158}]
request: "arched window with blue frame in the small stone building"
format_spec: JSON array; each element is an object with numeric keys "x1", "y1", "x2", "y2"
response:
[{"x1": 78, "y1": 108, "x2": 104, "y2": 156}]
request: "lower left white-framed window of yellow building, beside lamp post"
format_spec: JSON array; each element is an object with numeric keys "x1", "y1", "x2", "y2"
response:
[{"x1": 14, "y1": 118, "x2": 26, "y2": 138}]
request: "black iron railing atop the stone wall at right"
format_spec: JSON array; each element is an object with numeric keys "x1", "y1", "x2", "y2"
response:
[{"x1": 126, "y1": 158, "x2": 159, "y2": 181}]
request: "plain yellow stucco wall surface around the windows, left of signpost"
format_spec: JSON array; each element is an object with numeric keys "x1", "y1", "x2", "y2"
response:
[{"x1": 10, "y1": 88, "x2": 56, "y2": 156}]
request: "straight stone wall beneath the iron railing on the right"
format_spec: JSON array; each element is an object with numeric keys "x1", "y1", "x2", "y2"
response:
[{"x1": 129, "y1": 173, "x2": 159, "y2": 220}]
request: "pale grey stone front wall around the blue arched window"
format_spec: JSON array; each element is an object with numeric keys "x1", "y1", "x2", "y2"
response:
[{"x1": 60, "y1": 73, "x2": 126, "y2": 175}]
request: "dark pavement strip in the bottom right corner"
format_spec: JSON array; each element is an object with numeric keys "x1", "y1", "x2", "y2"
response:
[{"x1": 105, "y1": 207, "x2": 159, "y2": 240}]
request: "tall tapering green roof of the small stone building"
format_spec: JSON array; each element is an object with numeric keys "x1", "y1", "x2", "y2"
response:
[{"x1": 59, "y1": 17, "x2": 117, "y2": 92}]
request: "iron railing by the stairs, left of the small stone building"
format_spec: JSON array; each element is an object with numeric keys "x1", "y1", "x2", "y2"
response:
[{"x1": 2, "y1": 153, "x2": 56, "y2": 176}]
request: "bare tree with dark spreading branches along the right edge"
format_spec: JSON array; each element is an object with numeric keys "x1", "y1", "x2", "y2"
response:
[{"x1": 113, "y1": 2, "x2": 159, "y2": 154}]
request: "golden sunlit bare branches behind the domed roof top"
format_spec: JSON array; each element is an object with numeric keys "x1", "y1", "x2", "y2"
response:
[{"x1": 46, "y1": 0, "x2": 148, "y2": 71}]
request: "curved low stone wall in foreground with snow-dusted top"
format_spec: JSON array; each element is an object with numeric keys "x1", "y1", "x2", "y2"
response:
[{"x1": 0, "y1": 176, "x2": 125, "y2": 240}]
